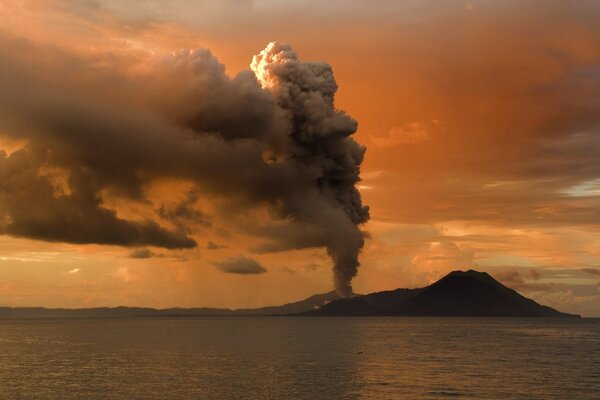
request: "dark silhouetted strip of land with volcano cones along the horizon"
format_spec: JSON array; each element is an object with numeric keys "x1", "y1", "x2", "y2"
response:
[{"x1": 0, "y1": 270, "x2": 579, "y2": 319}]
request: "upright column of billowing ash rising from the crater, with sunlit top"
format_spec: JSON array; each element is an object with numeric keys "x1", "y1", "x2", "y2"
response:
[{"x1": 251, "y1": 42, "x2": 369, "y2": 297}]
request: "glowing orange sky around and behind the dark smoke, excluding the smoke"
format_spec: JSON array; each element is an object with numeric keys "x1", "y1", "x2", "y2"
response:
[{"x1": 0, "y1": 0, "x2": 600, "y2": 316}]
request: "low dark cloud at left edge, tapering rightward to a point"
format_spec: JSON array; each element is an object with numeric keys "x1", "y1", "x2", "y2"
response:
[{"x1": 0, "y1": 150, "x2": 196, "y2": 249}]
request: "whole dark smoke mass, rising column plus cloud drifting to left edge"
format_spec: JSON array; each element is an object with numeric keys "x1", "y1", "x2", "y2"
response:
[{"x1": 0, "y1": 37, "x2": 368, "y2": 295}]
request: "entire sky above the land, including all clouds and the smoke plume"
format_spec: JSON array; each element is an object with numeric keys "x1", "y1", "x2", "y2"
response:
[{"x1": 0, "y1": 0, "x2": 600, "y2": 317}]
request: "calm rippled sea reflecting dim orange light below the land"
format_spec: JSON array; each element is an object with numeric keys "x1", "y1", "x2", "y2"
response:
[{"x1": 0, "y1": 317, "x2": 600, "y2": 400}]
